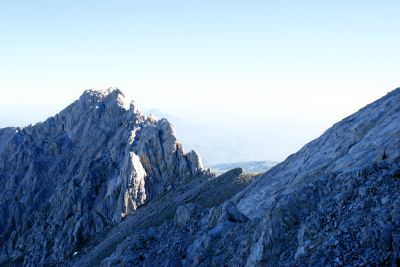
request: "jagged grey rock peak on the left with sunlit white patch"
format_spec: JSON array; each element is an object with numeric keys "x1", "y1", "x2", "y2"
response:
[{"x1": 0, "y1": 89, "x2": 202, "y2": 266}]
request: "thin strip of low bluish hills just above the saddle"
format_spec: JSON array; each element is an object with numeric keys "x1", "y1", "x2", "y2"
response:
[{"x1": 209, "y1": 161, "x2": 278, "y2": 173}]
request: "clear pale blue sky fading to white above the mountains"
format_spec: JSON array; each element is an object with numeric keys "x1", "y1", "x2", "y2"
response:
[{"x1": 0, "y1": 0, "x2": 400, "y2": 161}]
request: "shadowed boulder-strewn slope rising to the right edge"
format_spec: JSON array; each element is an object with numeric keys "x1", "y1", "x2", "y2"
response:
[{"x1": 72, "y1": 89, "x2": 400, "y2": 266}]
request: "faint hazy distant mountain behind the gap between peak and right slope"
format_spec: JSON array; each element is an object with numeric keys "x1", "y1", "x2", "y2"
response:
[{"x1": 145, "y1": 109, "x2": 288, "y2": 168}]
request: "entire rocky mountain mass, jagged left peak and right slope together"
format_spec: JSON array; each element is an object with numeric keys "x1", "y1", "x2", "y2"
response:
[{"x1": 0, "y1": 89, "x2": 400, "y2": 267}]
